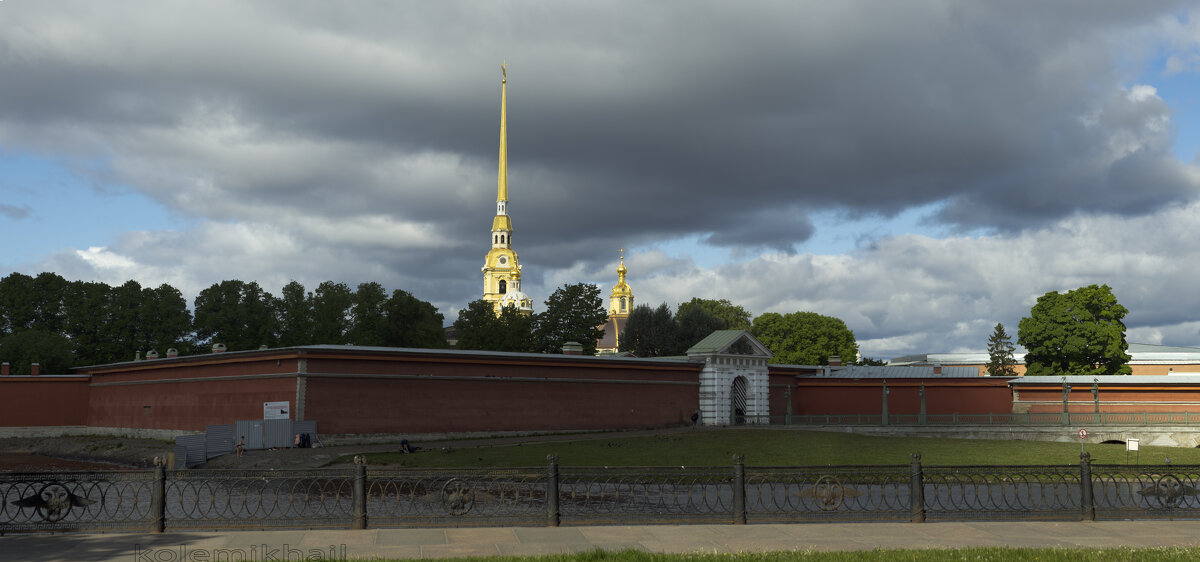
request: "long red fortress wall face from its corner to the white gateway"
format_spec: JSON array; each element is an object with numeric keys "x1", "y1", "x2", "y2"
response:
[{"x1": 304, "y1": 354, "x2": 701, "y2": 434}]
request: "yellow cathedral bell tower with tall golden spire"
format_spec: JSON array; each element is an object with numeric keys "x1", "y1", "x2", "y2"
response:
[{"x1": 482, "y1": 65, "x2": 533, "y2": 315}]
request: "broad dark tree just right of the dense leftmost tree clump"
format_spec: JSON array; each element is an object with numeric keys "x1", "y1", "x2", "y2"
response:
[{"x1": 194, "y1": 280, "x2": 278, "y2": 351}]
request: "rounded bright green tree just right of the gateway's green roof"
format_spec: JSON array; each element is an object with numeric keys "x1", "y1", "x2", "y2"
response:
[{"x1": 751, "y1": 312, "x2": 858, "y2": 365}]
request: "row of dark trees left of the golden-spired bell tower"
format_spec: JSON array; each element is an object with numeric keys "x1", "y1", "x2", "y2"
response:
[{"x1": 0, "y1": 273, "x2": 446, "y2": 375}]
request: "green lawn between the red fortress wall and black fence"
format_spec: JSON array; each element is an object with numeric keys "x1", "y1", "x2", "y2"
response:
[{"x1": 334, "y1": 428, "x2": 1200, "y2": 467}]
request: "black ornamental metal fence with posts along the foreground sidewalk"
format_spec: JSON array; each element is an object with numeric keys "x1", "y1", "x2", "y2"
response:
[{"x1": 0, "y1": 454, "x2": 1200, "y2": 533}]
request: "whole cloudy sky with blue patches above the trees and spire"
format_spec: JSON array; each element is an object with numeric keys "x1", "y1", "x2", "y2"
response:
[{"x1": 0, "y1": 0, "x2": 1200, "y2": 358}]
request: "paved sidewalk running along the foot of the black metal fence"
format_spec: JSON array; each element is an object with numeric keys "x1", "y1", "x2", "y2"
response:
[{"x1": 0, "y1": 521, "x2": 1200, "y2": 562}]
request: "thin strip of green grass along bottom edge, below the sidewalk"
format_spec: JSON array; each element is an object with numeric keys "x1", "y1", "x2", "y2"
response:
[{"x1": 340, "y1": 548, "x2": 1200, "y2": 562}]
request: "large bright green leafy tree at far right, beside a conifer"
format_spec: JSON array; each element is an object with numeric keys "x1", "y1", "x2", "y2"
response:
[{"x1": 1016, "y1": 285, "x2": 1132, "y2": 376}]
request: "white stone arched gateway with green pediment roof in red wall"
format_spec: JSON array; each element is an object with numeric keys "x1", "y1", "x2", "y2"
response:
[{"x1": 688, "y1": 330, "x2": 772, "y2": 425}]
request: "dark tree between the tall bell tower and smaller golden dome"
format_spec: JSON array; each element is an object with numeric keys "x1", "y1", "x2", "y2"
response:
[{"x1": 534, "y1": 283, "x2": 608, "y2": 355}]
